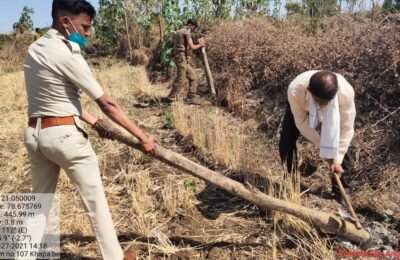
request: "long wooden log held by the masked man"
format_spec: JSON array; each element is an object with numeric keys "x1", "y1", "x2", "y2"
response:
[{"x1": 103, "y1": 121, "x2": 370, "y2": 244}]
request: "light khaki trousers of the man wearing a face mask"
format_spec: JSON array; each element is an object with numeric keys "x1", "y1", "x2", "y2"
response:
[{"x1": 25, "y1": 117, "x2": 123, "y2": 260}]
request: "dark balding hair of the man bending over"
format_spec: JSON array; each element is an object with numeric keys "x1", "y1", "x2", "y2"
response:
[{"x1": 308, "y1": 70, "x2": 338, "y2": 100}]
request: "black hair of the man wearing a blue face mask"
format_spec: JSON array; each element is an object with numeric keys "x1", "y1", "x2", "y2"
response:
[{"x1": 51, "y1": 0, "x2": 96, "y2": 20}]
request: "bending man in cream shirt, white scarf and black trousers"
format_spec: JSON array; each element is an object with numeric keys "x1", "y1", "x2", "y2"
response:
[{"x1": 279, "y1": 70, "x2": 356, "y2": 201}]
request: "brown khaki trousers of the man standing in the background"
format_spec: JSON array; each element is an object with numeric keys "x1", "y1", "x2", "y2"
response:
[{"x1": 169, "y1": 53, "x2": 198, "y2": 98}]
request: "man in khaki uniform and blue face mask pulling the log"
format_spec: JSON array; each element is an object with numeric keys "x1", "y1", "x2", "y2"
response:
[{"x1": 24, "y1": 0, "x2": 155, "y2": 260}]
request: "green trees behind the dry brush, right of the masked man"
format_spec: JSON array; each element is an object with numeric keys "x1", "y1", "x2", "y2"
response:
[{"x1": 95, "y1": 0, "x2": 388, "y2": 67}]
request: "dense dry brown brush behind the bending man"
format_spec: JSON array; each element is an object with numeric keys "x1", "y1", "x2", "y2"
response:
[{"x1": 207, "y1": 16, "x2": 400, "y2": 242}]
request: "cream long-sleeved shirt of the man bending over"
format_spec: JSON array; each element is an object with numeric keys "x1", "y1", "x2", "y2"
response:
[{"x1": 288, "y1": 70, "x2": 356, "y2": 163}]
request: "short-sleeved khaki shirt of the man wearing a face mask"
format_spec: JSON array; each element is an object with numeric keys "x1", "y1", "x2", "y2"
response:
[{"x1": 24, "y1": 29, "x2": 104, "y2": 117}]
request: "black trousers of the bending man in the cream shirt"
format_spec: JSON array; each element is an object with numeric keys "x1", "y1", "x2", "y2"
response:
[{"x1": 279, "y1": 104, "x2": 351, "y2": 193}]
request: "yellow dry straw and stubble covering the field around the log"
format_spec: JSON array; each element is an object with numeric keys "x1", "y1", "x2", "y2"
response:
[{"x1": 0, "y1": 57, "x2": 384, "y2": 259}]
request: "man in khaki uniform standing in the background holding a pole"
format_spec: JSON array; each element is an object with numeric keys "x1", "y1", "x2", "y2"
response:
[{"x1": 168, "y1": 20, "x2": 205, "y2": 104}]
